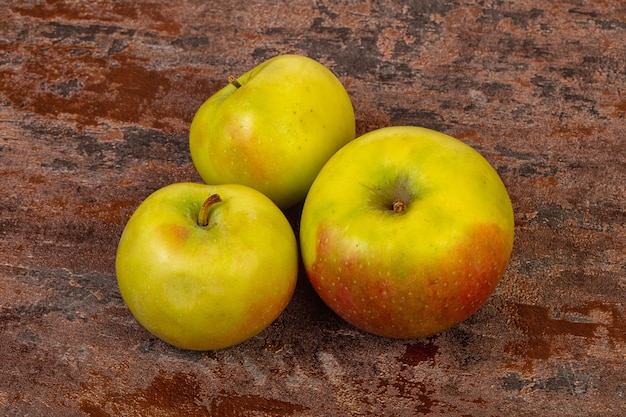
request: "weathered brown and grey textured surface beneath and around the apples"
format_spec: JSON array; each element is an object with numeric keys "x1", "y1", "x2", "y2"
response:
[{"x1": 0, "y1": 0, "x2": 626, "y2": 417}]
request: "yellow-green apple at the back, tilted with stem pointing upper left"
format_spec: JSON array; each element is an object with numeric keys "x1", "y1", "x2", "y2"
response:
[{"x1": 189, "y1": 55, "x2": 355, "y2": 209}]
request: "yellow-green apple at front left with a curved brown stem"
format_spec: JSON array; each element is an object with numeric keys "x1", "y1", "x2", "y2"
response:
[{"x1": 115, "y1": 183, "x2": 299, "y2": 350}]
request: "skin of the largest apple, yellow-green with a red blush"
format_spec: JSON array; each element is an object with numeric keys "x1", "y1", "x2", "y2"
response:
[{"x1": 300, "y1": 126, "x2": 514, "y2": 338}]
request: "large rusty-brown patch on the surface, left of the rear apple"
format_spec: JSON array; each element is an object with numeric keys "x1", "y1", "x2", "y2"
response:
[{"x1": 0, "y1": 44, "x2": 213, "y2": 131}]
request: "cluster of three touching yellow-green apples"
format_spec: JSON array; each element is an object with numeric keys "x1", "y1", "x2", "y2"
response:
[{"x1": 116, "y1": 55, "x2": 514, "y2": 350}]
